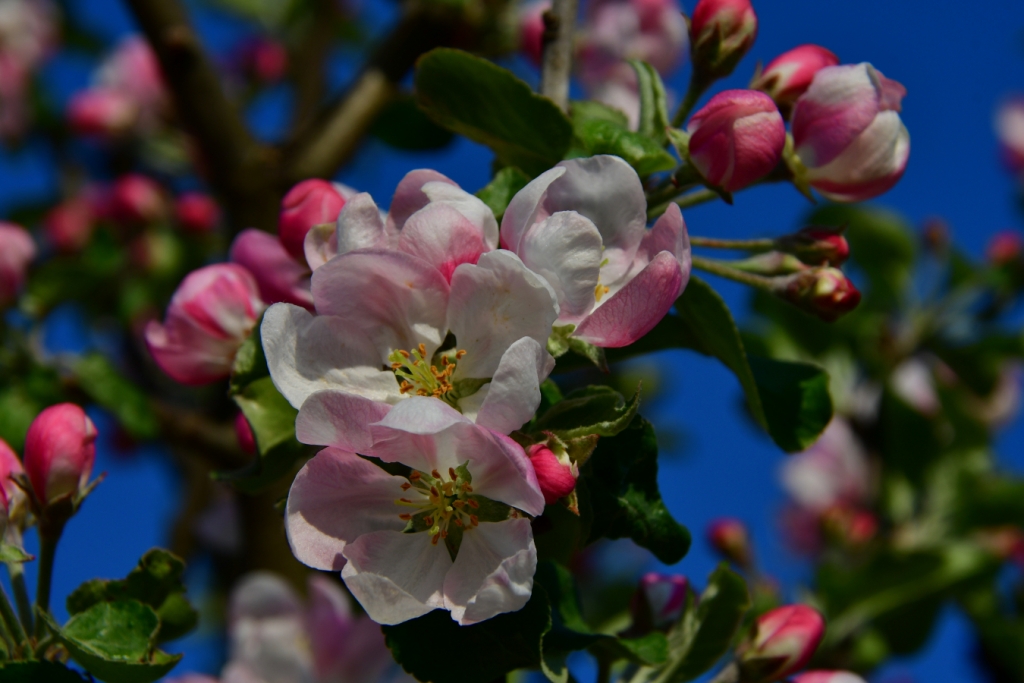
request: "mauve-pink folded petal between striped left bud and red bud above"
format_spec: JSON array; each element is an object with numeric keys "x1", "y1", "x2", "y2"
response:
[{"x1": 228, "y1": 228, "x2": 313, "y2": 309}]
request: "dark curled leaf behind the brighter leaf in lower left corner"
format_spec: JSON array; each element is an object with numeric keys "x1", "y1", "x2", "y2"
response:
[{"x1": 67, "y1": 548, "x2": 199, "y2": 643}]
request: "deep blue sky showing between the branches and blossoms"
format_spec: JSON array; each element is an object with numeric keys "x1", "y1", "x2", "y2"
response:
[{"x1": 6, "y1": 0, "x2": 1024, "y2": 683}]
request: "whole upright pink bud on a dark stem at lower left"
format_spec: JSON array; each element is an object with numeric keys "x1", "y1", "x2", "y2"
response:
[{"x1": 25, "y1": 403, "x2": 96, "y2": 505}]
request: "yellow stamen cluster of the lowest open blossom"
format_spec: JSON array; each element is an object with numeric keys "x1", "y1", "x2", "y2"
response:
[{"x1": 395, "y1": 466, "x2": 480, "y2": 546}]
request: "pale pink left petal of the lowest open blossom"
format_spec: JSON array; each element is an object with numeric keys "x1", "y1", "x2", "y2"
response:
[{"x1": 285, "y1": 447, "x2": 406, "y2": 571}]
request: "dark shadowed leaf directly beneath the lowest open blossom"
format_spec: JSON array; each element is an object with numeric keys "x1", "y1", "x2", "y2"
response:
[{"x1": 382, "y1": 585, "x2": 551, "y2": 683}]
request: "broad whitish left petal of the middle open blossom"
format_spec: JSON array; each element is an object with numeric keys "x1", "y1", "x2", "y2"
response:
[{"x1": 260, "y1": 303, "x2": 401, "y2": 408}]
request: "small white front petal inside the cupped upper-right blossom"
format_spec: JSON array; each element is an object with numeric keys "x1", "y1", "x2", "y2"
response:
[{"x1": 519, "y1": 211, "x2": 604, "y2": 325}]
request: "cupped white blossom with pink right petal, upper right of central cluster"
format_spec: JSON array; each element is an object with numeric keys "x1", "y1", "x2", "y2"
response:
[{"x1": 501, "y1": 155, "x2": 690, "y2": 347}]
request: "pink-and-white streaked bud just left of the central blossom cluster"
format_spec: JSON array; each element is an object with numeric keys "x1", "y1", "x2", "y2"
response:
[{"x1": 145, "y1": 263, "x2": 263, "y2": 384}]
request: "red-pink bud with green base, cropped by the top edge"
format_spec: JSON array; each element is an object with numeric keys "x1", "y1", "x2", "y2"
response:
[{"x1": 690, "y1": 0, "x2": 758, "y2": 79}]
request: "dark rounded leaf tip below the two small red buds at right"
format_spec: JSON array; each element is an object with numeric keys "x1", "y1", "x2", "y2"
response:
[{"x1": 748, "y1": 355, "x2": 833, "y2": 453}]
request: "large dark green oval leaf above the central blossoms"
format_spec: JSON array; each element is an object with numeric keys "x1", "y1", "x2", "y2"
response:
[{"x1": 414, "y1": 48, "x2": 572, "y2": 176}]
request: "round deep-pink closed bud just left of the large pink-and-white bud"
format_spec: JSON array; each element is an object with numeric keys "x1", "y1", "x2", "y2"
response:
[{"x1": 687, "y1": 90, "x2": 785, "y2": 193}]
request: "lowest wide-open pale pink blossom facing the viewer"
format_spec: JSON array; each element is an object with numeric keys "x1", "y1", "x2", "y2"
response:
[{"x1": 286, "y1": 396, "x2": 544, "y2": 626}]
